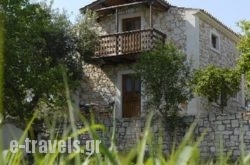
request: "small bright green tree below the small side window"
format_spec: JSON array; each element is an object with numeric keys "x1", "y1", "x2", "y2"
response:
[{"x1": 192, "y1": 65, "x2": 241, "y2": 112}]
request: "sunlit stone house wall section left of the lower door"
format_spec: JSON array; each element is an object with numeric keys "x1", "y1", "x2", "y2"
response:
[{"x1": 78, "y1": 64, "x2": 119, "y2": 108}]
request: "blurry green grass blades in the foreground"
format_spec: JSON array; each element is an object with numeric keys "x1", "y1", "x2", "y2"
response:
[{"x1": 1, "y1": 105, "x2": 250, "y2": 165}]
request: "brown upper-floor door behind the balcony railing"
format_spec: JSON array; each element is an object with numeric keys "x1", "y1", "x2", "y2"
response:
[{"x1": 122, "y1": 17, "x2": 141, "y2": 54}]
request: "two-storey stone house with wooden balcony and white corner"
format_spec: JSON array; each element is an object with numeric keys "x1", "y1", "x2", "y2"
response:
[{"x1": 79, "y1": 0, "x2": 244, "y2": 118}]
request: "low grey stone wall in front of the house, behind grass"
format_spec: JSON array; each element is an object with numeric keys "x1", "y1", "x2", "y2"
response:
[{"x1": 77, "y1": 112, "x2": 250, "y2": 159}]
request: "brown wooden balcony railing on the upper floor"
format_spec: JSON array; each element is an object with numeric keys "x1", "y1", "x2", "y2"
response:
[{"x1": 95, "y1": 29, "x2": 166, "y2": 57}]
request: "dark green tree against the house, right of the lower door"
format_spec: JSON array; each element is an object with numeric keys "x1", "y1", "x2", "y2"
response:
[{"x1": 136, "y1": 43, "x2": 191, "y2": 116}]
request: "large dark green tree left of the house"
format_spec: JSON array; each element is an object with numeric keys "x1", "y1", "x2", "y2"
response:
[{"x1": 1, "y1": 0, "x2": 97, "y2": 120}]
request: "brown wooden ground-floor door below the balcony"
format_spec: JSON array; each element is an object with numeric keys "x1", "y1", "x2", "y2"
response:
[{"x1": 122, "y1": 74, "x2": 141, "y2": 117}]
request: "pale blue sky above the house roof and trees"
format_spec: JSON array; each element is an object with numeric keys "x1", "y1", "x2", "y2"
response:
[{"x1": 53, "y1": 0, "x2": 250, "y2": 32}]
